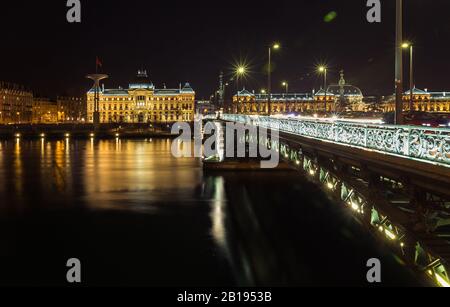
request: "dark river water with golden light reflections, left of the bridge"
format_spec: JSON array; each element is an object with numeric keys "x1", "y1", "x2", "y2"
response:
[{"x1": 0, "y1": 140, "x2": 415, "y2": 286}]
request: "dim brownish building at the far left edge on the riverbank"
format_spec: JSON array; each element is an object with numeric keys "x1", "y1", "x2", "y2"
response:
[{"x1": 0, "y1": 82, "x2": 33, "y2": 124}]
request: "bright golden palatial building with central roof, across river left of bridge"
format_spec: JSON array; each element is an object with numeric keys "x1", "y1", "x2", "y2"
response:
[{"x1": 87, "y1": 71, "x2": 195, "y2": 123}]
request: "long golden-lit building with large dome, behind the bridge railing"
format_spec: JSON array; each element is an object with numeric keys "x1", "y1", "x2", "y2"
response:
[{"x1": 233, "y1": 72, "x2": 367, "y2": 114}]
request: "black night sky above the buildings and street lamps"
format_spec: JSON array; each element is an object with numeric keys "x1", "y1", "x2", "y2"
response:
[{"x1": 0, "y1": 0, "x2": 450, "y2": 98}]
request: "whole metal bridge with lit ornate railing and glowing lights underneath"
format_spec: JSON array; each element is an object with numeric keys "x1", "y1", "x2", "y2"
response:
[{"x1": 204, "y1": 114, "x2": 450, "y2": 287}]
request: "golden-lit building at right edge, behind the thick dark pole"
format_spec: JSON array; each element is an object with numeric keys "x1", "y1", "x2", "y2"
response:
[{"x1": 381, "y1": 88, "x2": 450, "y2": 113}]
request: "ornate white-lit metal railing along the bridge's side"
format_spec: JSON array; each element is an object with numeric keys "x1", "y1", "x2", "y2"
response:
[{"x1": 221, "y1": 114, "x2": 450, "y2": 167}]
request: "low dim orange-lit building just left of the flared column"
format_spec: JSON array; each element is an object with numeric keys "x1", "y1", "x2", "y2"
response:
[{"x1": 56, "y1": 96, "x2": 87, "y2": 123}]
